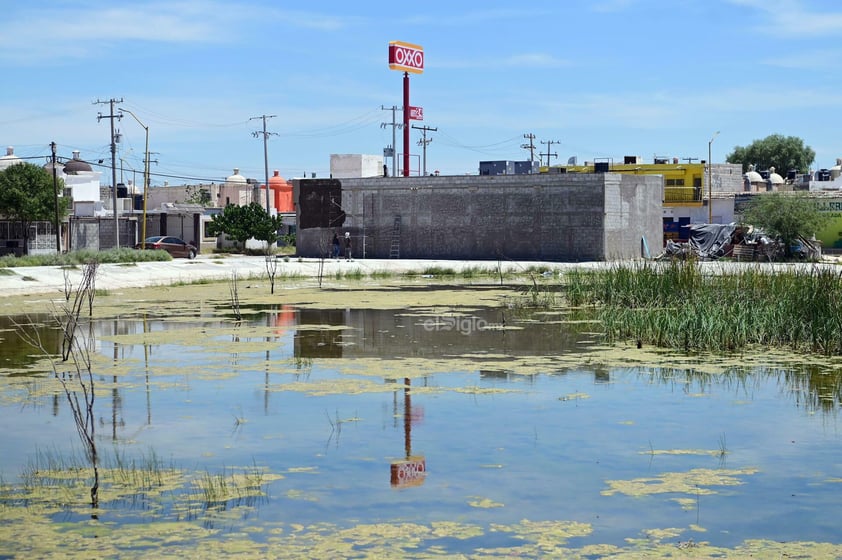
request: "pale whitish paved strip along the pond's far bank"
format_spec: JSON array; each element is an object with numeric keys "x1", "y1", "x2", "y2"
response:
[{"x1": 0, "y1": 255, "x2": 596, "y2": 298}]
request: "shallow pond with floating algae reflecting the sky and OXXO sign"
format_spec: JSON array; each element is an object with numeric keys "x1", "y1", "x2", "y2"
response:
[{"x1": 0, "y1": 285, "x2": 842, "y2": 558}]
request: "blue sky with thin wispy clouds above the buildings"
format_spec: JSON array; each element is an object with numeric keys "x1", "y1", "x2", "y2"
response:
[{"x1": 0, "y1": 0, "x2": 842, "y2": 185}]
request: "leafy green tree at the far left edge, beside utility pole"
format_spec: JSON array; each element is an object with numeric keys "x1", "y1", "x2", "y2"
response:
[{"x1": 0, "y1": 163, "x2": 70, "y2": 255}]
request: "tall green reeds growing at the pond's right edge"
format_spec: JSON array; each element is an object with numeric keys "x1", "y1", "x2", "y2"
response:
[{"x1": 564, "y1": 261, "x2": 842, "y2": 355}]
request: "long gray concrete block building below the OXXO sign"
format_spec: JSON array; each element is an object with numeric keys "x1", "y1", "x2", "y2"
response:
[{"x1": 294, "y1": 173, "x2": 663, "y2": 261}]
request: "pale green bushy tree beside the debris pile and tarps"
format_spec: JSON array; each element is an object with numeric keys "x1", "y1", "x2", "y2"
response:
[{"x1": 742, "y1": 192, "x2": 828, "y2": 257}]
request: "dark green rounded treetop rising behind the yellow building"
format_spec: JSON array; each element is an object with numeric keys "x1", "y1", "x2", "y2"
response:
[{"x1": 725, "y1": 134, "x2": 816, "y2": 175}]
